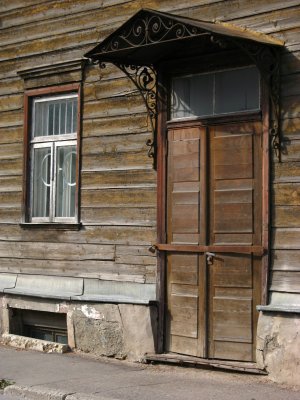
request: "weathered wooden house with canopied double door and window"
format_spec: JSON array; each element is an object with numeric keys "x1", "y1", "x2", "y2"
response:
[{"x1": 0, "y1": 0, "x2": 300, "y2": 384}]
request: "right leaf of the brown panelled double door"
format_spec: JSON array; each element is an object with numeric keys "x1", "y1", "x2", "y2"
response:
[{"x1": 208, "y1": 123, "x2": 262, "y2": 361}]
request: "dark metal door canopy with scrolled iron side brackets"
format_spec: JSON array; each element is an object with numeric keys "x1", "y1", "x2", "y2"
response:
[{"x1": 85, "y1": 9, "x2": 284, "y2": 164}]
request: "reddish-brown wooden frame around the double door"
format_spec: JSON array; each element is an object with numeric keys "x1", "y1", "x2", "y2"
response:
[{"x1": 157, "y1": 68, "x2": 270, "y2": 353}]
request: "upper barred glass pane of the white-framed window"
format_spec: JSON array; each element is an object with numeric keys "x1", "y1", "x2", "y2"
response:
[{"x1": 33, "y1": 97, "x2": 77, "y2": 137}]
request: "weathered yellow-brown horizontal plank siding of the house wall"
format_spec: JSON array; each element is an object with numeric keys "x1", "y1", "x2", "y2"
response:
[{"x1": 0, "y1": 0, "x2": 300, "y2": 300}]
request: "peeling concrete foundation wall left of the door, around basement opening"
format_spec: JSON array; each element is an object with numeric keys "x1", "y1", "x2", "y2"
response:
[{"x1": 0, "y1": 296, "x2": 157, "y2": 361}]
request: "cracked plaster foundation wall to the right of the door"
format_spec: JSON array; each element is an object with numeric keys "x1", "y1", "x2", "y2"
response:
[{"x1": 257, "y1": 311, "x2": 300, "y2": 386}]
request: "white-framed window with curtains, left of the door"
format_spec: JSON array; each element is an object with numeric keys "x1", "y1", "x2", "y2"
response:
[{"x1": 23, "y1": 85, "x2": 79, "y2": 223}]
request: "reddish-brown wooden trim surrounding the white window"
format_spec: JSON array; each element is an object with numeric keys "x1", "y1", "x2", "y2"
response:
[{"x1": 20, "y1": 83, "x2": 82, "y2": 229}]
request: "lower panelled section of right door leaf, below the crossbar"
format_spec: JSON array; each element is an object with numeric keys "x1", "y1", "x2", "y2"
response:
[{"x1": 209, "y1": 254, "x2": 253, "y2": 361}]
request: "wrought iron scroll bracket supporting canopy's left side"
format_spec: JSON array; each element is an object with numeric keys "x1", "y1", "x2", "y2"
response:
[{"x1": 99, "y1": 62, "x2": 157, "y2": 169}]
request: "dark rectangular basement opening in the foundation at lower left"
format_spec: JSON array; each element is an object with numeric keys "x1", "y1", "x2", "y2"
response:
[{"x1": 10, "y1": 308, "x2": 68, "y2": 344}]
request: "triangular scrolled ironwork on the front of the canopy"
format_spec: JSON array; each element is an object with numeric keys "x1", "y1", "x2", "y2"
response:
[{"x1": 97, "y1": 11, "x2": 205, "y2": 55}]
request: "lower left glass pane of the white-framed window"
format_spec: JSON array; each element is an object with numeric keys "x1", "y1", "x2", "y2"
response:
[{"x1": 32, "y1": 147, "x2": 51, "y2": 217}]
